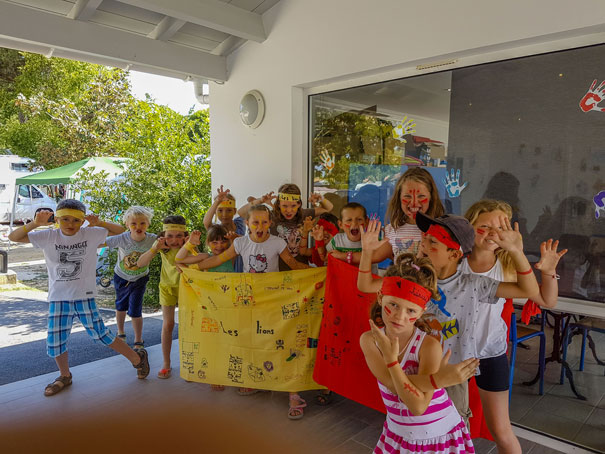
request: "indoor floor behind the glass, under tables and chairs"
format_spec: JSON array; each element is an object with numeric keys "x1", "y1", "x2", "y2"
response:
[{"x1": 510, "y1": 320, "x2": 605, "y2": 452}]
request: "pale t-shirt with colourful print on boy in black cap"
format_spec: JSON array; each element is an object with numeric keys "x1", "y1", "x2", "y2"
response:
[{"x1": 423, "y1": 269, "x2": 500, "y2": 364}]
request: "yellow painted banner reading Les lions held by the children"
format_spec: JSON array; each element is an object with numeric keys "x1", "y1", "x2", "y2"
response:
[{"x1": 179, "y1": 268, "x2": 326, "y2": 391}]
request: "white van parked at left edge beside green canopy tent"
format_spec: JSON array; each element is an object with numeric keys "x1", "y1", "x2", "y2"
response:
[{"x1": 0, "y1": 154, "x2": 57, "y2": 222}]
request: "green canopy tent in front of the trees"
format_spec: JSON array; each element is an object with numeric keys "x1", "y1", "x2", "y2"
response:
[{"x1": 10, "y1": 157, "x2": 128, "y2": 230}]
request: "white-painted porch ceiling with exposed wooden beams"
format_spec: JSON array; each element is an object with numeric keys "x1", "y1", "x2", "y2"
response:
[{"x1": 0, "y1": 0, "x2": 279, "y2": 82}]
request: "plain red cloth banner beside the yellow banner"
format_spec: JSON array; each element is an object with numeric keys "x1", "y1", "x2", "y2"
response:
[{"x1": 313, "y1": 256, "x2": 385, "y2": 413}]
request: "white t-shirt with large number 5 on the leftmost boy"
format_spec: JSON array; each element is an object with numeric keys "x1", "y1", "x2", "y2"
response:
[{"x1": 27, "y1": 227, "x2": 107, "y2": 301}]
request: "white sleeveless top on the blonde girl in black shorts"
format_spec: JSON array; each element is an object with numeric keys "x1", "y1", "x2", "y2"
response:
[{"x1": 459, "y1": 258, "x2": 508, "y2": 358}]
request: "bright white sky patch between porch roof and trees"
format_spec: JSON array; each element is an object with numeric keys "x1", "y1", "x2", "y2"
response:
[{"x1": 130, "y1": 71, "x2": 208, "y2": 115}]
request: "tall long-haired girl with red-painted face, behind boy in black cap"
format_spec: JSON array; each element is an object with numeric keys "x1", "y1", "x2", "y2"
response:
[{"x1": 372, "y1": 167, "x2": 445, "y2": 263}]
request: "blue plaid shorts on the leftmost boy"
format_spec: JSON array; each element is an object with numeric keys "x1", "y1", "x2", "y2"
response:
[{"x1": 46, "y1": 298, "x2": 115, "y2": 358}]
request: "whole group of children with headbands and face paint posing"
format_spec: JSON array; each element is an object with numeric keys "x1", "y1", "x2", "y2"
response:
[{"x1": 10, "y1": 167, "x2": 566, "y2": 453}]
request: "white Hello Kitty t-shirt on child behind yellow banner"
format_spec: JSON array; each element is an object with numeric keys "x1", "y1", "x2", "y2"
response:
[{"x1": 233, "y1": 235, "x2": 286, "y2": 273}]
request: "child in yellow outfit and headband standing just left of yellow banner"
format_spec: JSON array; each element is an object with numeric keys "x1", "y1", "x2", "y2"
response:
[{"x1": 137, "y1": 215, "x2": 188, "y2": 379}]
